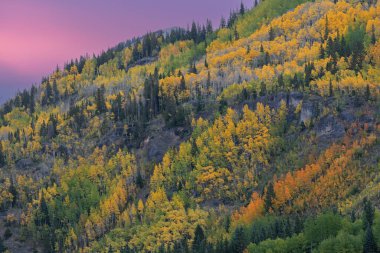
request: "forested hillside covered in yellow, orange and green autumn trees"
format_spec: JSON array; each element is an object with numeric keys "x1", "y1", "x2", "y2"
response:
[{"x1": 0, "y1": 0, "x2": 380, "y2": 253}]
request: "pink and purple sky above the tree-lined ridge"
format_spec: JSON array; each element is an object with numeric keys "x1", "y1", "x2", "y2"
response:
[{"x1": 0, "y1": 0, "x2": 253, "y2": 103}]
